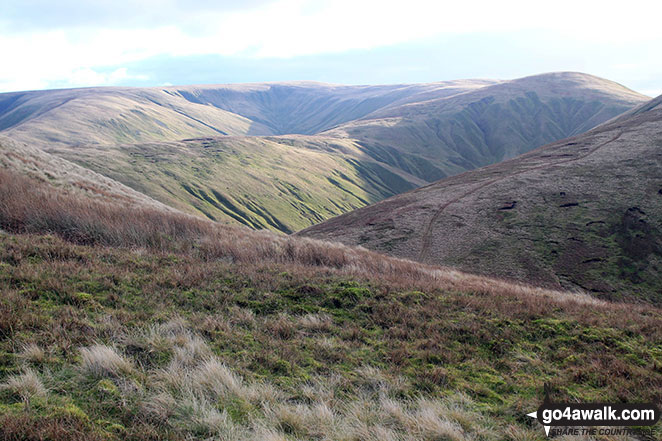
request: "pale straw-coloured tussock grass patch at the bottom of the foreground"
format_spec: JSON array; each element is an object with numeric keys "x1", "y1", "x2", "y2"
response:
[{"x1": 71, "y1": 321, "x2": 498, "y2": 441}]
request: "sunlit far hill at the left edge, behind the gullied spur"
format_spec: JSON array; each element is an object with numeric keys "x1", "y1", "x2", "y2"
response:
[{"x1": 0, "y1": 88, "x2": 269, "y2": 145}]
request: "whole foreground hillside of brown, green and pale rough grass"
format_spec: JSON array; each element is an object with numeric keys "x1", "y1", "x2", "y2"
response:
[{"x1": 0, "y1": 167, "x2": 662, "y2": 440}]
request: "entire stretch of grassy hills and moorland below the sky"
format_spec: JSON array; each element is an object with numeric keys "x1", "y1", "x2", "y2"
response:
[{"x1": 0, "y1": 73, "x2": 662, "y2": 441}]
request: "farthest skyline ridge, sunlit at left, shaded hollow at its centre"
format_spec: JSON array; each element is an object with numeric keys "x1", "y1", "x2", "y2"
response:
[{"x1": 0, "y1": 80, "x2": 490, "y2": 145}]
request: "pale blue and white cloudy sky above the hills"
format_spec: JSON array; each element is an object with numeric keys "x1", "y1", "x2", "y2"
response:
[{"x1": 0, "y1": 0, "x2": 662, "y2": 96}]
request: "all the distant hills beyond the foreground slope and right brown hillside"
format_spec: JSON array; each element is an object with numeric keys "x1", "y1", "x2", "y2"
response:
[{"x1": 0, "y1": 73, "x2": 647, "y2": 233}]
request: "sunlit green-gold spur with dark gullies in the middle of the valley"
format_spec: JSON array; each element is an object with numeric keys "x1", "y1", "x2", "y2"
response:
[{"x1": 46, "y1": 136, "x2": 424, "y2": 232}]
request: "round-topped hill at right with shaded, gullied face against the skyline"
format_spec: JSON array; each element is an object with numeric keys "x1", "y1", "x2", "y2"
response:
[{"x1": 325, "y1": 72, "x2": 650, "y2": 182}]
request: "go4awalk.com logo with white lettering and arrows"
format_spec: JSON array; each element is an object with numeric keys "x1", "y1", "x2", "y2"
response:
[{"x1": 527, "y1": 384, "x2": 660, "y2": 436}]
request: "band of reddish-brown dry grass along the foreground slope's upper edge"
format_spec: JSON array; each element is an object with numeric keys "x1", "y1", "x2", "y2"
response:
[{"x1": 0, "y1": 169, "x2": 657, "y2": 326}]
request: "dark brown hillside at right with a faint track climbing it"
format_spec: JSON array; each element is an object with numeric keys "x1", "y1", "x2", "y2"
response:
[{"x1": 300, "y1": 97, "x2": 662, "y2": 304}]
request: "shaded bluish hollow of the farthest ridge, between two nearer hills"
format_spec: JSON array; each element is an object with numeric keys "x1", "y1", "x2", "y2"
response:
[{"x1": 166, "y1": 80, "x2": 497, "y2": 135}]
